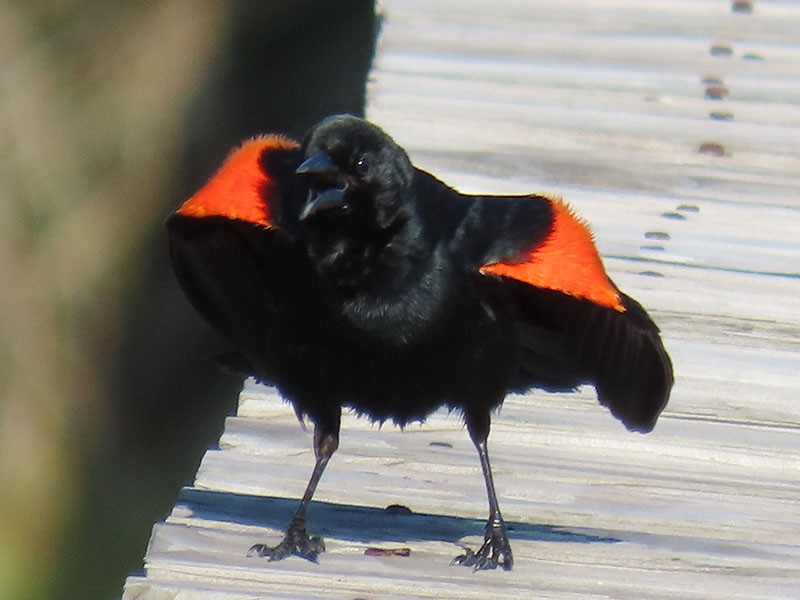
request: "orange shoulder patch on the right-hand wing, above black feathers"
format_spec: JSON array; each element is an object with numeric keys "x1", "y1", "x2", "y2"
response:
[{"x1": 480, "y1": 198, "x2": 625, "y2": 312}]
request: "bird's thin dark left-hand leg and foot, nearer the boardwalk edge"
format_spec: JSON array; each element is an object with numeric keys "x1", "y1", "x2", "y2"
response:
[{"x1": 247, "y1": 415, "x2": 340, "y2": 562}]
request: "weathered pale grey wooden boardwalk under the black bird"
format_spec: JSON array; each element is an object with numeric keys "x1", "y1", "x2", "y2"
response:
[{"x1": 124, "y1": 0, "x2": 800, "y2": 600}]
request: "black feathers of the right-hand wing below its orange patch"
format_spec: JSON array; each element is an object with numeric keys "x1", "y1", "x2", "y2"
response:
[{"x1": 505, "y1": 280, "x2": 673, "y2": 432}]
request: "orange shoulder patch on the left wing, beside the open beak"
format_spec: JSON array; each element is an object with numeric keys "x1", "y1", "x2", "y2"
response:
[{"x1": 178, "y1": 135, "x2": 299, "y2": 227}]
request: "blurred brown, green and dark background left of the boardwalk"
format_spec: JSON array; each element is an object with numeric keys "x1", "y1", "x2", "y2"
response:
[{"x1": 0, "y1": 0, "x2": 377, "y2": 600}]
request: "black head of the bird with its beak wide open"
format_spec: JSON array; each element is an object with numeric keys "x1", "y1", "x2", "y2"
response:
[{"x1": 297, "y1": 115, "x2": 414, "y2": 229}]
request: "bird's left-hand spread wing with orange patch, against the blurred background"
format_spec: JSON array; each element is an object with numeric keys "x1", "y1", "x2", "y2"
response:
[{"x1": 167, "y1": 136, "x2": 302, "y2": 378}]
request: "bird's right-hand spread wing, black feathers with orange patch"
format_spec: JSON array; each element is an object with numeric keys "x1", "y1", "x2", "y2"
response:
[{"x1": 472, "y1": 196, "x2": 673, "y2": 432}]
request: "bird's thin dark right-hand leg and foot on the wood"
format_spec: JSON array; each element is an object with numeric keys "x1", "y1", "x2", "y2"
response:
[{"x1": 453, "y1": 412, "x2": 514, "y2": 571}]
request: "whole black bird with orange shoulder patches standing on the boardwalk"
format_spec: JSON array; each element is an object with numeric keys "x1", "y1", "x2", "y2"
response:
[{"x1": 167, "y1": 115, "x2": 673, "y2": 569}]
